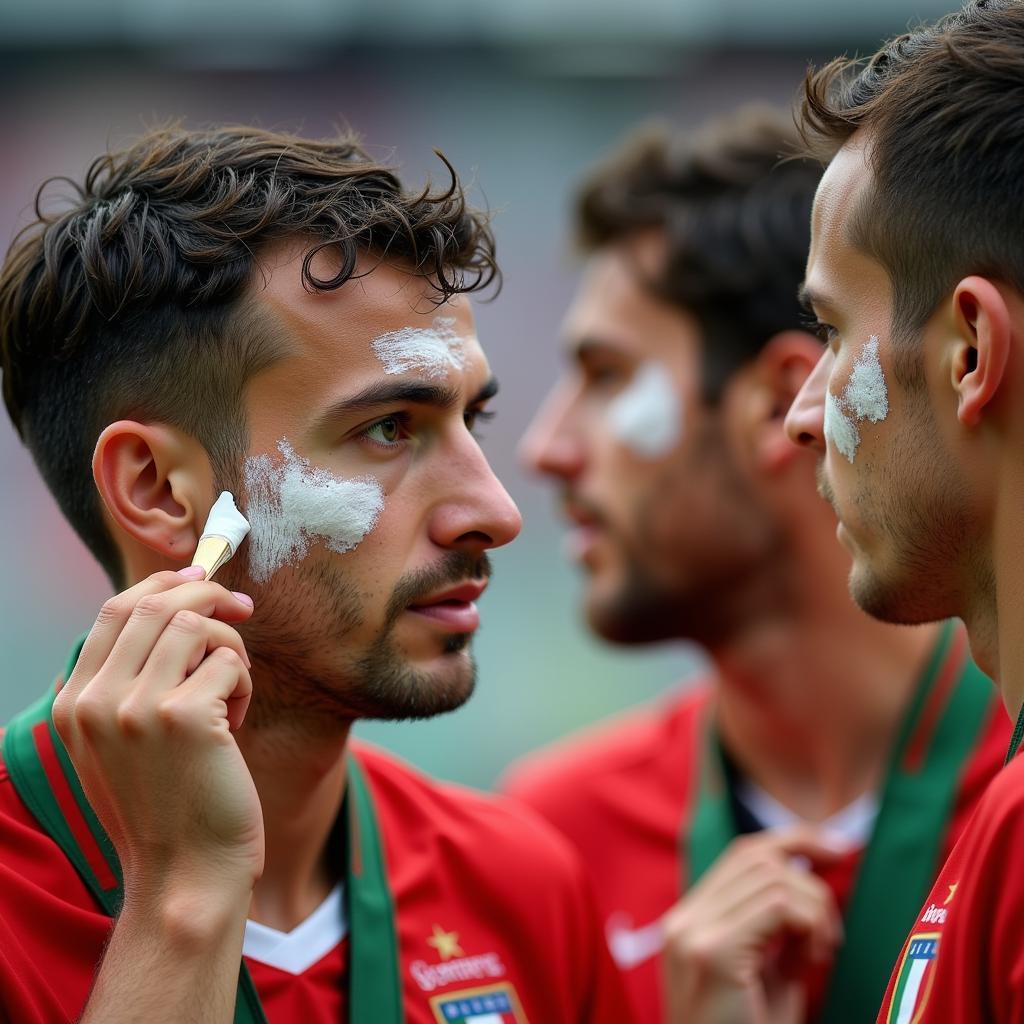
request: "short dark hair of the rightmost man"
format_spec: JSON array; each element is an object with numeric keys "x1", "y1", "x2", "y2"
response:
[{"x1": 801, "y1": 0, "x2": 1024, "y2": 366}]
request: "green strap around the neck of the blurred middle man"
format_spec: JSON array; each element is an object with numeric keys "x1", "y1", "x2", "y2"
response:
[{"x1": 684, "y1": 624, "x2": 992, "y2": 1024}]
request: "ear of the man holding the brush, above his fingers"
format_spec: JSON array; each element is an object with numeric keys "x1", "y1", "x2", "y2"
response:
[{"x1": 92, "y1": 420, "x2": 213, "y2": 563}]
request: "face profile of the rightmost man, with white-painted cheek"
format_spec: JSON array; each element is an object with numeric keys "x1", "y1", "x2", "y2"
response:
[{"x1": 786, "y1": 140, "x2": 973, "y2": 623}]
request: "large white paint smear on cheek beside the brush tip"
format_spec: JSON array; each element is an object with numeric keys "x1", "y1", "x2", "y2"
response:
[{"x1": 246, "y1": 438, "x2": 384, "y2": 583}]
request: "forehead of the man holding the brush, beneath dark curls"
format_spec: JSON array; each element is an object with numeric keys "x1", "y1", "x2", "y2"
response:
[{"x1": 251, "y1": 244, "x2": 488, "y2": 426}]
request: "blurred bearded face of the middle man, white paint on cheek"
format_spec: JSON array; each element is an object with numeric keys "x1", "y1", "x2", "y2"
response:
[{"x1": 520, "y1": 233, "x2": 775, "y2": 643}]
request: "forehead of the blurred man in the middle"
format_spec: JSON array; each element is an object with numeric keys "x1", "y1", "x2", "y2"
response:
[{"x1": 562, "y1": 234, "x2": 698, "y2": 358}]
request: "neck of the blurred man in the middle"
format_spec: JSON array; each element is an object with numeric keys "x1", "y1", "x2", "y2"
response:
[{"x1": 712, "y1": 602, "x2": 939, "y2": 821}]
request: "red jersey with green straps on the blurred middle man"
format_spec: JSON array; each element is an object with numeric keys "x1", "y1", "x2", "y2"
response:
[{"x1": 504, "y1": 626, "x2": 1011, "y2": 1024}]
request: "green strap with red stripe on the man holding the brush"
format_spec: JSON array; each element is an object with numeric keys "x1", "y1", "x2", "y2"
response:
[{"x1": 3, "y1": 641, "x2": 404, "y2": 1024}]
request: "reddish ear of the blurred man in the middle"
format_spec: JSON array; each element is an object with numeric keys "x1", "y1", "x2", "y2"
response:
[{"x1": 745, "y1": 331, "x2": 821, "y2": 474}]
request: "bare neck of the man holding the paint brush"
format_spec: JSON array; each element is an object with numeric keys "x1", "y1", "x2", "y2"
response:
[{"x1": 237, "y1": 708, "x2": 350, "y2": 932}]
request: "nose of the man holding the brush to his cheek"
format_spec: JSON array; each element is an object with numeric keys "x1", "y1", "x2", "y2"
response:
[{"x1": 430, "y1": 434, "x2": 522, "y2": 551}]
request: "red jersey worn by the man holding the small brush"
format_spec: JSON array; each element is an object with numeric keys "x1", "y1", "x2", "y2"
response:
[{"x1": 0, "y1": 725, "x2": 630, "y2": 1024}]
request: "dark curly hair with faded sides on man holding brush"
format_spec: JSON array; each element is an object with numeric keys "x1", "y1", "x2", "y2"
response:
[{"x1": 0, "y1": 126, "x2": 499, "y2": 584}]
